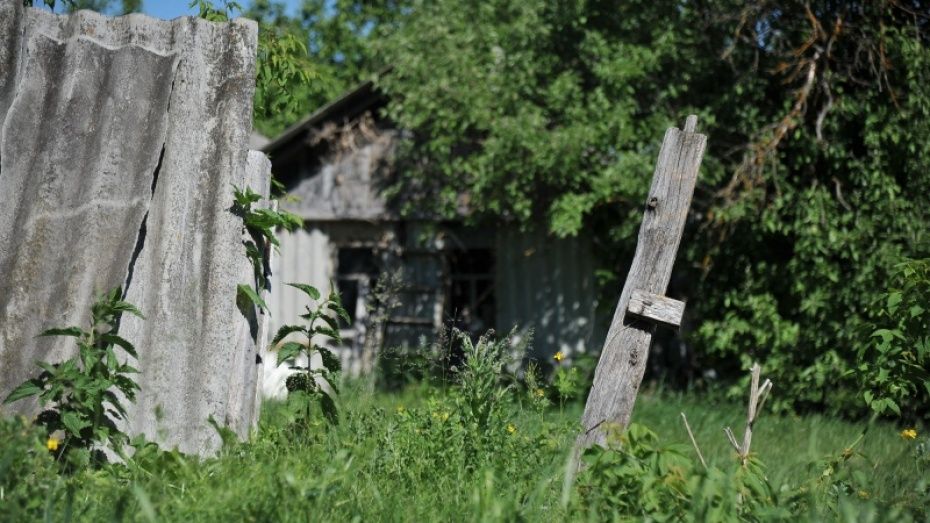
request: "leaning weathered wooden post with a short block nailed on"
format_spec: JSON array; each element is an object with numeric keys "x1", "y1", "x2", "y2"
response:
[{"x1": 577, "y1": 115, "x2": 707, "y2": 450}]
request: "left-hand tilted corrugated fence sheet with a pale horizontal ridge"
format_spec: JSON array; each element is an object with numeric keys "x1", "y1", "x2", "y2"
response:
[{"x1": 0, "y1": 35, "x2": 177, "y2": 410}]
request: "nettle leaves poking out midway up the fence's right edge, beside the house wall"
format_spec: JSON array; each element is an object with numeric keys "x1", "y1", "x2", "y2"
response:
[{"x1": 232, "y1": 186, "x2": 303, "y2": 311}]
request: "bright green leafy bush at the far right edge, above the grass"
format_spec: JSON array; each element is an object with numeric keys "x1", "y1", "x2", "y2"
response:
[{"x1": 854, "y1": 259, "x2": 930, "y2": 418}]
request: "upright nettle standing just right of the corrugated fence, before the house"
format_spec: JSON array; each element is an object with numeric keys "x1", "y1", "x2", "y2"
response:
[{"x1": 272, "y1": 283, "x2": 350, "y2": 423}]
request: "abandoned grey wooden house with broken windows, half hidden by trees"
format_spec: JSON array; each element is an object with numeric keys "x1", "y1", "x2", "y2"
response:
[{"x1": 263, "y1": 82, "x2": 596, "y2": 380}]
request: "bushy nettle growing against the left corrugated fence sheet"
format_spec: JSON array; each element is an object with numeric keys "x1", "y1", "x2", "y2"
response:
[{"x1": 4, "y1": 287, "x2": 143, "y2": 464}]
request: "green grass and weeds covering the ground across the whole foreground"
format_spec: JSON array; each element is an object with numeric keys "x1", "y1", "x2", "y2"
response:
[{"x1": 0, "y1": 334, "x2": 930, "y2": 522}]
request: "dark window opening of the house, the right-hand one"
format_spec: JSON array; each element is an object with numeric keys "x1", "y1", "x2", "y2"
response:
[{"x1": 446, "y1": 249, "x2": 497, "y2": 334}]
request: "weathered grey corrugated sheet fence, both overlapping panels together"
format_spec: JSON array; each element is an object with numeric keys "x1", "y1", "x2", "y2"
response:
[{"x1": 0, "y1": 0, "x2": 268, "y2": 453}]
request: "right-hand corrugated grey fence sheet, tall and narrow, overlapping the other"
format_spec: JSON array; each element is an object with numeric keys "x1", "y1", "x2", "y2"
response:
[{"x1": 116, "y1": 14, "x2": 260, "y2": 453}]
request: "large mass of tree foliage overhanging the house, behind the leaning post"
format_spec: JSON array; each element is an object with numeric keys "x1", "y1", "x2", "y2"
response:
[{"x1": 375, "y1": 0, "x2": 930, "y2": 415}]
